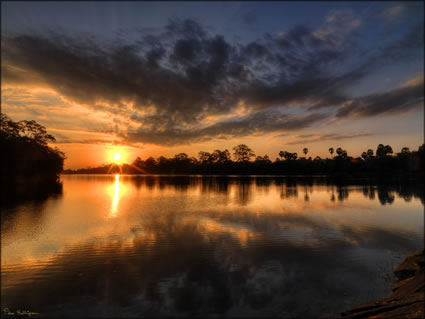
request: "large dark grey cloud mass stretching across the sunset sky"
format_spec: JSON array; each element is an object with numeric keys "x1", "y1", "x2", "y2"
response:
[{"x1": 2, "y1": 18, "x2": 423, "y2": 144}]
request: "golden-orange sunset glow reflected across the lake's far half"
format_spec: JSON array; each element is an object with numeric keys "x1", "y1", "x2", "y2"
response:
[{"x1": 1, "y1": 175, "x2": 424, "y2": 270}]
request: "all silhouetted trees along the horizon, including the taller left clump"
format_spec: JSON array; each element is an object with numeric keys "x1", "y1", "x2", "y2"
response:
[{"x1": 0, "y1": 114, "x2": 424, "y2": 178}]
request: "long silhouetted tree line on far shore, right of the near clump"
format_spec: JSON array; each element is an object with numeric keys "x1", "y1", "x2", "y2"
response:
[{"x1": 64, "y1": 144, "x2": 424, "y2": 175}]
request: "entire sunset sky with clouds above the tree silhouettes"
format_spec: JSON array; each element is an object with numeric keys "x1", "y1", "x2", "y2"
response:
[{"x1": 1, "y1": 1, "x2": 424, "y2": 168}]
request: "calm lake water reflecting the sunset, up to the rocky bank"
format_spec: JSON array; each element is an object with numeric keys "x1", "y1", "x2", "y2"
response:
[{"x1": 1, "y1": 175, "x2": 424, "y2": 317}]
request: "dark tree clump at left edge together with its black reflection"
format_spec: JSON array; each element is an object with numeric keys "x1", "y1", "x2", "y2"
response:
[{"x1": 0, "y1": 113, "x2": 66, "y2": 204}]
